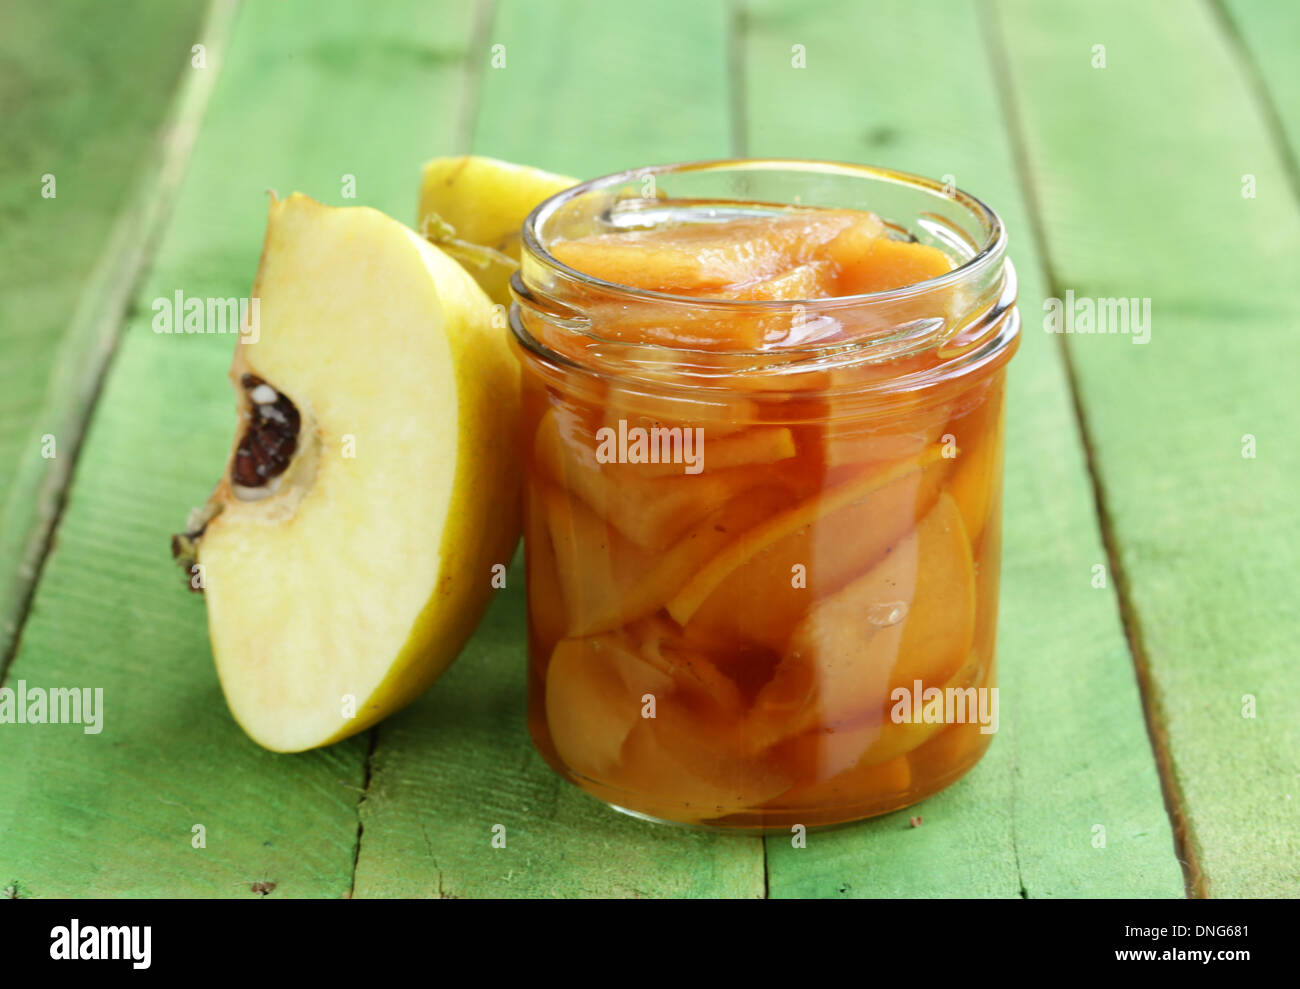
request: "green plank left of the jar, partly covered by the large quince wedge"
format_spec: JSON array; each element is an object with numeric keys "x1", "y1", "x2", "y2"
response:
[{"x1": 0, "y1": 0, "x2": 483, "y2": 897}]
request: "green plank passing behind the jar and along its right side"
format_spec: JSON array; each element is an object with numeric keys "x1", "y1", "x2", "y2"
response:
[{"x1": 744, "y1": 0, "x2": 1183, "y2": 897}]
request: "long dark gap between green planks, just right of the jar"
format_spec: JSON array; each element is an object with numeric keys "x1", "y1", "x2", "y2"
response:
[{"x1": 976, "y1": 0, "x2": 1196, "y2": 898}]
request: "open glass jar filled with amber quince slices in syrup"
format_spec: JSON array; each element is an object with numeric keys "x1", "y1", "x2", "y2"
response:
[{"x1": 511, "y1": 160, "x2": 1019, "y2": 830}]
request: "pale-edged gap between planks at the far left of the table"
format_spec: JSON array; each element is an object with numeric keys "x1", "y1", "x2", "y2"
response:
[{"x1": 0, "y1": 0, "x2": 238, "y2": 684}]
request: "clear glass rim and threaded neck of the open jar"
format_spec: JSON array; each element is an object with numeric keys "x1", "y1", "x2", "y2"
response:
[{"x1": 510, "y1": 159, "x2": 1019, "y2": 391}]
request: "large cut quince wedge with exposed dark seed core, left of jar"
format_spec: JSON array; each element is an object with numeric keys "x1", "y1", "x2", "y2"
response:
[{"x1": 178, "y1": 194, "x2": 520, "y2": 751}]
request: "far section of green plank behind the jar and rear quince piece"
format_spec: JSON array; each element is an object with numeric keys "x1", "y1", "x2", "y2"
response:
[{"x1": 462, "y1": 0, "x2": 731, "y2": 178}]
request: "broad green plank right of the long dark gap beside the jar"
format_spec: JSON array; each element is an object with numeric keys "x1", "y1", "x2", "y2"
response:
[{"x1": 997, "y1": 0, "x2": 1300, "y2": 897}]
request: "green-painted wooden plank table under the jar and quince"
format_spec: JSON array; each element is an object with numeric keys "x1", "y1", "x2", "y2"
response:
[{"x1": 0, "y1": 0, "x2": 1300, "y2": 897}]
